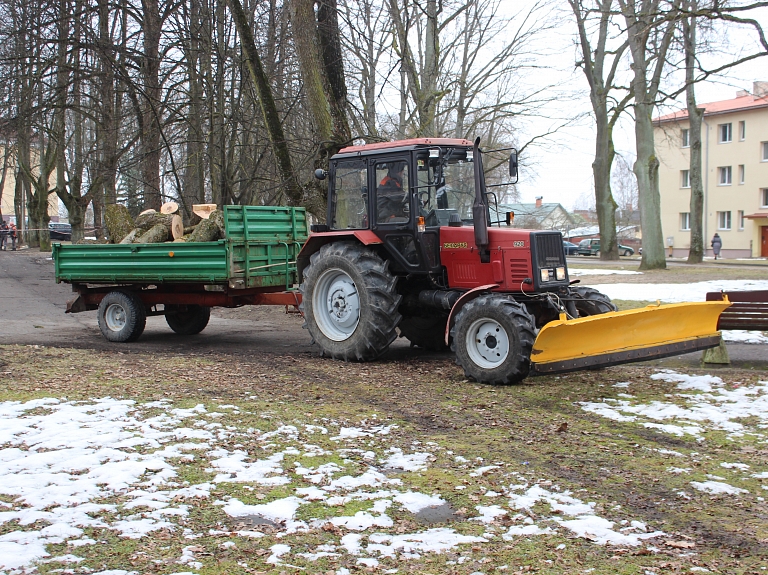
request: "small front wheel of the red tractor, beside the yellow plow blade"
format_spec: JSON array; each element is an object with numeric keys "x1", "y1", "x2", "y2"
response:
[{"x1": 451, "y1": 295, "x2": 536, "y2": 385}]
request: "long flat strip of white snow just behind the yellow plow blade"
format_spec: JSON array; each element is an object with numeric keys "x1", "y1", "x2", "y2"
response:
[{"x1": 589, "y1": 280, "x2": 768, "y2": 303}]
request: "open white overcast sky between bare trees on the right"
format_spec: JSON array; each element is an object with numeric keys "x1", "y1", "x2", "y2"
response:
[{"x1": 515, "y1": 0, "x2": 768, "y2": 209}]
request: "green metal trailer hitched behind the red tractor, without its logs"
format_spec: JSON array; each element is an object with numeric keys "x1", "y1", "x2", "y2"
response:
[{"x1": 53, "y1": 206, "x2": 308, "y2": 342}]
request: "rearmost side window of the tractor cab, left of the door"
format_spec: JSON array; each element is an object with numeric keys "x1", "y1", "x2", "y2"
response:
[{"x1": 331, "y1": 160, "x2": 368, "y2": 230}]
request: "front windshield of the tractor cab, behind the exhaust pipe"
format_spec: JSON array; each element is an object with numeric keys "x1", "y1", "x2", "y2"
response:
[{"x1": 417, "y1": 148, "x2": 475, "y2": 226}]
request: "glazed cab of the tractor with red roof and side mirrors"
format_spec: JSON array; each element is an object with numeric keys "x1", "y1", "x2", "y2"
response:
[{"x1": 316, "y1": 138, "x2": 517, "y2": 274}]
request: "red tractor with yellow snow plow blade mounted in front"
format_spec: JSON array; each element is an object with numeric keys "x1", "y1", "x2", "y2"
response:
[{"x1": 298, "y1": 138, "x2": 720, "y2": 384}]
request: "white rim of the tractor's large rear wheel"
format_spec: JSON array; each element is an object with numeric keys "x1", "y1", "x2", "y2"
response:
[{"x1": 312, "y1": 268, "x2": 360, "y2": 341}]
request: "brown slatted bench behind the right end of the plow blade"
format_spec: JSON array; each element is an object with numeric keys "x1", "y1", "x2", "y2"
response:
[{"x1": 701, "y1": 290, "x2": 768, "y2": 364}]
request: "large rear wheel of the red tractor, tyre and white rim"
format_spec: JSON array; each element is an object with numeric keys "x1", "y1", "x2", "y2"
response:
[{"x1": 301, "y1": 242, "x2": 402, "y2": 361}]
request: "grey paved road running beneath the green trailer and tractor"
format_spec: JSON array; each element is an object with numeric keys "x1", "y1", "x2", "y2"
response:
[{"x1": 0, "y1": 249, "x2": 768, "y2": 372}]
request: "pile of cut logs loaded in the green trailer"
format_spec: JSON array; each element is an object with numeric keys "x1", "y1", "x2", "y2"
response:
[{"x1": 104, "y1": 202, "x2": 224, "y2": 244}]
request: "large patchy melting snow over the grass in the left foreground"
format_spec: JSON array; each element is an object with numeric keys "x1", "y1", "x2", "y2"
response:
[{"x1": 0, "y1": 398, "x2": 676, "y2": 574}]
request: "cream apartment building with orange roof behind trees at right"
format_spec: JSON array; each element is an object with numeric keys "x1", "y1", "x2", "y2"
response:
[{"x1": 654, "y1": 82, "x2": 768, "y2": 258}]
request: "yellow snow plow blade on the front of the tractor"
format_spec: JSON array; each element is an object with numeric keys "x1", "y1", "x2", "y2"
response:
[{"x1": 531, "y1": 301, "x2": 731, "y2": 373}]
